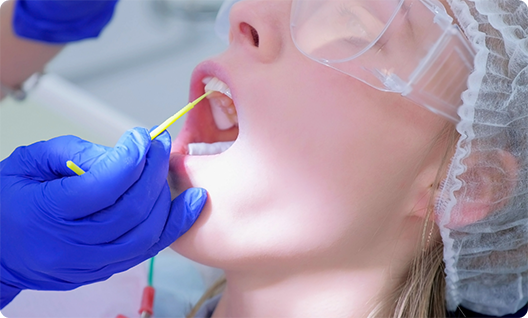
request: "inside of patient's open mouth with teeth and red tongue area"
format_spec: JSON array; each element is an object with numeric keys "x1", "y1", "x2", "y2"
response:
[{"x1": 178, "y1": 77, "x2": 239, "y2": 156}]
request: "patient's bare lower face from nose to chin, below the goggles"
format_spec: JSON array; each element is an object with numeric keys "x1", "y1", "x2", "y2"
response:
[{"x1": 171, "y1": 0, "x2": 454, "y2": 269}]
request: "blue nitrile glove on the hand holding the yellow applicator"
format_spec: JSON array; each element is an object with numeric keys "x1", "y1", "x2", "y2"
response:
[{"x1": 0, "y1": 128, "x2": 207, "y2": 308}]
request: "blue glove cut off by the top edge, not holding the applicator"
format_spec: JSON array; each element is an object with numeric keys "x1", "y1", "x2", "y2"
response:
[{"x1": 13, "y1": 0, "x2": 117, "y2": 43}]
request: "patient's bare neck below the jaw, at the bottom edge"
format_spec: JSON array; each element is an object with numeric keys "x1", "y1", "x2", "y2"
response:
[{"x1": 209, "y1": 267, "x2": 401, "y2": 318}]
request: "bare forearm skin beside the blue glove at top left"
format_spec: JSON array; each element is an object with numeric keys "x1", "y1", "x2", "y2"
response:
[{"x1": 0, "y1": 0, "x2": 63, "y2": 99}]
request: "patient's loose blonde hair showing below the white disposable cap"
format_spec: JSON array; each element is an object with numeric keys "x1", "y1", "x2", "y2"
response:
[{"x1": 186, "y1": 124, "x2": 459, "y2": 318}]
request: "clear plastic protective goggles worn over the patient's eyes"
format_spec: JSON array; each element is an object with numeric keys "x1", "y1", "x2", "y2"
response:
[{"x1": 216, "y1": 0, "x2": 475, "y2": 122}]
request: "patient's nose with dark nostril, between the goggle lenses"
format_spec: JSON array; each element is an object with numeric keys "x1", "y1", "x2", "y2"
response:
[{"x1": 230, "y1": 0, "x2": 291, "y2": 63}]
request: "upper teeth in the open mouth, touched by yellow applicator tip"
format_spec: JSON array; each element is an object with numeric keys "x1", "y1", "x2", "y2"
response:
[{"x1": 203, "y1": 77, "x2": 238, "y2": 130}]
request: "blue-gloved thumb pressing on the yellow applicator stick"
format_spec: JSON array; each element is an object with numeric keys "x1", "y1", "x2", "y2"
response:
[{"x1": 41, "y1": 128, "x2": 154, "y2": 220}]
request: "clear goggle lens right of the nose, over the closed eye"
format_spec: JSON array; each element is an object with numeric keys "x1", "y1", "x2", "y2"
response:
[{"x1": 291, "y1": 0, "x2": 403, "y2": 62}]
